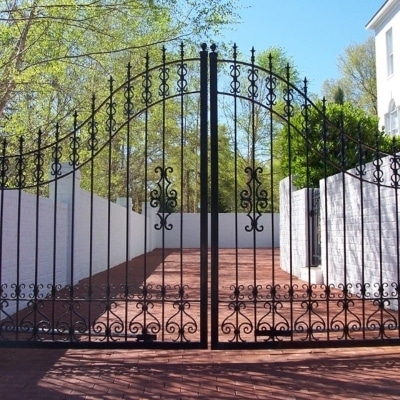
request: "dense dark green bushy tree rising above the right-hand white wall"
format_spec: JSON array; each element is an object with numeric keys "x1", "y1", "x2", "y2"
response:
[{"x1": 275, "y1": 101, "x2": 391, "y2": 188}]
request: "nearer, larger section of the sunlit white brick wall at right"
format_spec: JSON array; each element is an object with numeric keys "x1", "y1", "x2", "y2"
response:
[{"x1": 320, "y1": 157, "x2": 399, "y2": 297}]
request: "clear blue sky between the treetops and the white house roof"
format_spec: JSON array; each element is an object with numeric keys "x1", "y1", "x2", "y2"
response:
[{"x1": 216, "y1": 0, "x2": 385, "y2": 94}]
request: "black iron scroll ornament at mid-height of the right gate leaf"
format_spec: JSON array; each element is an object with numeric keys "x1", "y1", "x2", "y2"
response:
[{"x1": 240, "y1": 167, "x2": 268, "y2": 232}]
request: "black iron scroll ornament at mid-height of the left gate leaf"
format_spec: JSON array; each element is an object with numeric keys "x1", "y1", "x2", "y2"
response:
[{"x1": 150, "y1": 167, "x2": 178, "y2": 231}]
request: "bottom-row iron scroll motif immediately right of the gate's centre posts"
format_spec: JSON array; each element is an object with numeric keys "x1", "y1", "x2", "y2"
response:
[{"x1": 221, "y1": 285, "x2": 254, "y2": 342}]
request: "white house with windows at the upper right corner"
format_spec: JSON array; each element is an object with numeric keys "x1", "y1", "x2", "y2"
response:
[{"x1": 366, "y1": 0, "x2": 400, "y2": 135}]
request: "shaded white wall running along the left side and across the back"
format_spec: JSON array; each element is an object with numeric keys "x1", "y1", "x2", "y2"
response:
[{"x1": 0, "y1": 164, "x2": 279, "y2": 313}]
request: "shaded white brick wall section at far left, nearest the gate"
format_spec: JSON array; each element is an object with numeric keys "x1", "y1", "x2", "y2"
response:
[{"x1": 0, "y1": 190, "x2": 68, "y2": 297}]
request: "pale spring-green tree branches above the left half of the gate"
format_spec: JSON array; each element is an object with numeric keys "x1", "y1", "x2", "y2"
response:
[{"x1": 0, "y1": 0, "x2": 236, "y2": 136}]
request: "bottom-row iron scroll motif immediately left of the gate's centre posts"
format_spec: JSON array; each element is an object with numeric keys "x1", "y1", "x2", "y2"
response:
[{"x1": 165, "y1": 285, "x2": 198, "y2": 342}]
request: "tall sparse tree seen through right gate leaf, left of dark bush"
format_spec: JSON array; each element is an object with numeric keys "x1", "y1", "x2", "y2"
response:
[{"x1": 219, "y1": 47, "x2": 303, "y2": 212}]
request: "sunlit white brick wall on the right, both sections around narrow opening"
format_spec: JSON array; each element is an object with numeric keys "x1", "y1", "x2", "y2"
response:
[{"x1": 280, "y1": 153, "x2": 400, "y2": 308}]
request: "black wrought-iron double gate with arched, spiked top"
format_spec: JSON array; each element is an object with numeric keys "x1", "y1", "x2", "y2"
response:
[{"x1": 0, "y1": 45, "x2": 400, "y2": 349}]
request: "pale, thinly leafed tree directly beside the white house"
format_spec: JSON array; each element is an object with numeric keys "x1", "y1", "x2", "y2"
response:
[{"x1": 322, "y1": 37, "x2": 377, "y2": 115}]
